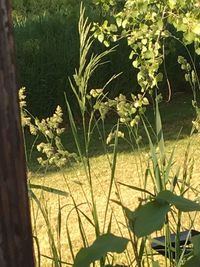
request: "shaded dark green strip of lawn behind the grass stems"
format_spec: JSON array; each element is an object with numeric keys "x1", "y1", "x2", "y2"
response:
[{"x1": 27, "y1": 94, "x2": 195, "y2": 175}]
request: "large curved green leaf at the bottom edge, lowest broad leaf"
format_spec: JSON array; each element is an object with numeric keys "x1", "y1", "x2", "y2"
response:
[{"x1": 73, "y1": 234, "x2": 128, "y2": 267}]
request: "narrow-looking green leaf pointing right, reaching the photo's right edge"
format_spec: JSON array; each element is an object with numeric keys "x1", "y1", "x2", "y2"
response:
[{"x1": 156, "y1": 190, "x2": 200, "y2": 212}]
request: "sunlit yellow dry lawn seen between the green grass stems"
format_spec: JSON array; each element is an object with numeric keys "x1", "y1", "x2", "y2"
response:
[{"x1": 28, "y1": 133, "x2": 200, "y2": 267}]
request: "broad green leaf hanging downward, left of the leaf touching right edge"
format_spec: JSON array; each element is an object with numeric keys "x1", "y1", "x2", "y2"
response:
[{"x1": 133, "y1": 201, "x2": 170, "y2": 237}]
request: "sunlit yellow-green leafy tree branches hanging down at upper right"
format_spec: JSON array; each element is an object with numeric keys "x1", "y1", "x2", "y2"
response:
[{"x1": 93, "y1": 0, "x2": 200, "y2": 92}]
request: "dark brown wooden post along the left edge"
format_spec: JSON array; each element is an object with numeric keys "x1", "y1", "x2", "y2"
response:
[{"x1": 0, "y1": 0, "x2": 34, "y2": 267}]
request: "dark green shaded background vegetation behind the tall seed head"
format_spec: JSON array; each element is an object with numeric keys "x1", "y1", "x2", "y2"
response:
[{"x1": 13, "y1": 0, "x2": 192, "y2": 117}]
